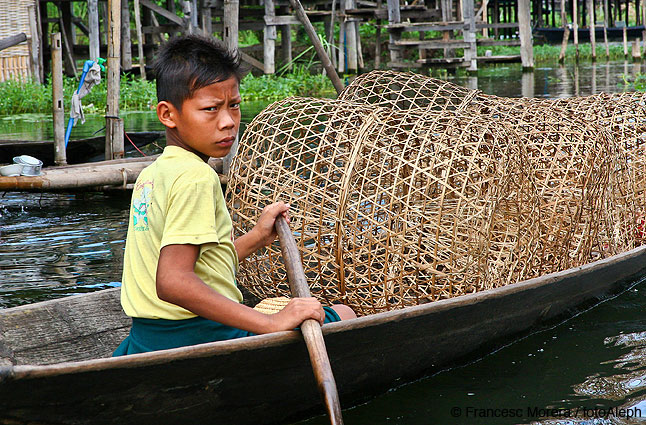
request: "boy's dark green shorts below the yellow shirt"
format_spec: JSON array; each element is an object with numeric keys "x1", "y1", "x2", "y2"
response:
[{"x1": 112, "y1": 307, "x2": 341, "y2": 357}]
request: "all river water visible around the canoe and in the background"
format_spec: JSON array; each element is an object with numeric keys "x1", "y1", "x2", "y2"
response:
[{"x1": 0, "y1": 61, "x2": 646, "y2": 425}]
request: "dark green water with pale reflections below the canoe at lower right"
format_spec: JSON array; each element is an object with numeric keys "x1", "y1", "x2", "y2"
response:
[{"x1": 300, "y1": 280, "x2": 646, "y2": 425}]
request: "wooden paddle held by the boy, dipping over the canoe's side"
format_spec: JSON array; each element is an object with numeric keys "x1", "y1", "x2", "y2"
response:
[{"x1": 275, "y1": 216, "x2": 343, "y2": 425}]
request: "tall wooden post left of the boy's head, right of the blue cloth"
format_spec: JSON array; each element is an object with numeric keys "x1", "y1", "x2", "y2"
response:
[{"x1": 105, "y1": 0, "x2": 123, "y2": 160}]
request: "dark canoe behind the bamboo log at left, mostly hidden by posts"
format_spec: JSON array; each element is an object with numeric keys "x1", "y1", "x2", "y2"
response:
[{"x1": 0, "y1": 131, "x2": 164, "y2": 166}]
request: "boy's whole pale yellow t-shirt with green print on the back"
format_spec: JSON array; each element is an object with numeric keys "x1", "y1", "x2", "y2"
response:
[{"x1": 121, "y1": 146, "x2": 242, "y2": 320}]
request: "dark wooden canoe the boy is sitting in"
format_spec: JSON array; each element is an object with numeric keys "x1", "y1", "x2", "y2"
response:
[{"x1": 0, "y1": 247, "x2": 646, "y2": 424}]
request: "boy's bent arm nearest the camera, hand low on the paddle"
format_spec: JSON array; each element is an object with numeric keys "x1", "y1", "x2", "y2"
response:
[{"x1": 156, "y1": 240, "x2": 325, "y2": 334}]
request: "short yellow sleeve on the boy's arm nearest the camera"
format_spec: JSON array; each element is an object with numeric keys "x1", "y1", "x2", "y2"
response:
[{"x1": 160, "y1": 171, "x2": 220, "y2": 245}]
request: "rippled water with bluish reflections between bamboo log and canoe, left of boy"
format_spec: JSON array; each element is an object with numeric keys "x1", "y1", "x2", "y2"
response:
[{"x1": 0, "y1": 193, "x2": 129, "y2": 308}]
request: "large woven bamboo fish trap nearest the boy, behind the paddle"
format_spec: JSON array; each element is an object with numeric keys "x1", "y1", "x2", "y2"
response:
[{"x1": 227, "y1": 98, "x2": 612, "y2": 314}]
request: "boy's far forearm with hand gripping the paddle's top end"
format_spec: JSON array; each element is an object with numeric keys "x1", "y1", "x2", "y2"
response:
[{"x1": 233, "y1": 202, "x2": 289, "y2": 261}]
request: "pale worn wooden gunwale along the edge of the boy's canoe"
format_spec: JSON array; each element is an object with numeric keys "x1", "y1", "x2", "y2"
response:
[{"x1": 0, "y1": 245, "x2": 646, "y2": 383}]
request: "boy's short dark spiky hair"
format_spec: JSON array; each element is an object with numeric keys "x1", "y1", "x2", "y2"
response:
[{"x1": 153, "y1": 34, "x2": 246, "y2": 110}]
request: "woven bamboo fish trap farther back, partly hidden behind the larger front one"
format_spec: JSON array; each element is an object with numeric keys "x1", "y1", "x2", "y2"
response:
[{"x1": 339, "y1": 71, "x2": 646, "y2": 255}]
